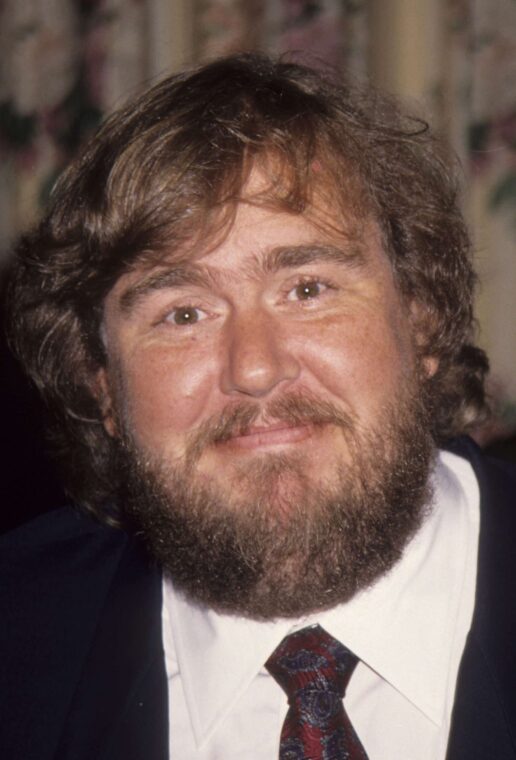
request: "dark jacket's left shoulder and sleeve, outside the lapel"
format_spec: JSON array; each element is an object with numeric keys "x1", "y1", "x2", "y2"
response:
[{"x1": 0, "y1": 507, "x2": 137, "y2": 760}]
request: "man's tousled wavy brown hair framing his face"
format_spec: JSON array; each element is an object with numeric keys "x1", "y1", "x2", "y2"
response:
[{"x1": 4, "y1": 54, "x2": 487, "y2": 519}]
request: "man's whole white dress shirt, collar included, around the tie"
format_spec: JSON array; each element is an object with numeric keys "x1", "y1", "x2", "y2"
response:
[{"x1": 163, "y1": 452, "x2": 479, "y2": 760}]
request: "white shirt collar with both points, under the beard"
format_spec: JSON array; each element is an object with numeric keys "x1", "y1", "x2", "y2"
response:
[{"x1": 164, "y1": 452, "x2": 479, "y2": 746}]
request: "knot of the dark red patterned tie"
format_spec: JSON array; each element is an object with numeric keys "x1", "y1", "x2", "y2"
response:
[{"x1": 265, "y1": 625, "x2": 357, "y2": 712}]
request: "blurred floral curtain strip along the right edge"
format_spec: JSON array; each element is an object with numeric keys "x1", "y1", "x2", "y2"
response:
[{"x1": 437, "y1": 0, "x2": 516, "y2": 437}]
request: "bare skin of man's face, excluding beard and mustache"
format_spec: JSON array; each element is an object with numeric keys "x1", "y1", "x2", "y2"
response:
[{"x1": 99, "y1": 189, "x2": 433, "y2": 504}]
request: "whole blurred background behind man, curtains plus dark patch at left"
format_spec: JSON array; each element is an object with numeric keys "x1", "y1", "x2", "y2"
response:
[{"x1": 0, "y1": 0, "x2": 516, "y2": 529}]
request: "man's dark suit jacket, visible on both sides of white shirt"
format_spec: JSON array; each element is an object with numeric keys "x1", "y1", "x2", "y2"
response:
[{"x1": 0, "y1": 436, "x2": 516, "y2": 760}]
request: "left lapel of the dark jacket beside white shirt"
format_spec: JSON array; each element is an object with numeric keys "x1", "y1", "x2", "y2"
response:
[{"x1": 56, "y1": 541, "x2": 168, "y2": 760}]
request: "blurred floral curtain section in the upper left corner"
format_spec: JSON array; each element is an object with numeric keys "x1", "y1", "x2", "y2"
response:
[{"x1": 0, "y1": 0, "x2": 147, "y2": 256}]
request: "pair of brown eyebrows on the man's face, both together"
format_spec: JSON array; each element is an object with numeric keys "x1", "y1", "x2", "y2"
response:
[{"x1": 119, "y1": 243, "x2": 367, "y2": 314}]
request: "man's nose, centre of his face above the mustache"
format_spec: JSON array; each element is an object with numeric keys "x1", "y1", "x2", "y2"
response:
[{"x1": 222, "y1": 310, "x2": 300, "y2": 398}]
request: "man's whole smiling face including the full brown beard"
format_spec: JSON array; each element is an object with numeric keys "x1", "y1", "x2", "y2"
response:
[{"x1": 102, "y1": 190, "x2": 431, "y2": 617}]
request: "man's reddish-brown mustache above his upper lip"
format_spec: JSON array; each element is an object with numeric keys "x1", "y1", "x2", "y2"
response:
[{"x1": 182, "y1": 393, "x2": 354, "y2": 462}]
